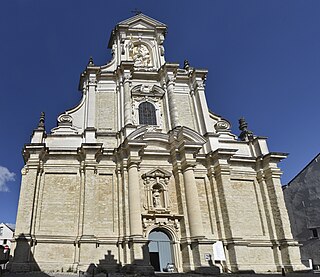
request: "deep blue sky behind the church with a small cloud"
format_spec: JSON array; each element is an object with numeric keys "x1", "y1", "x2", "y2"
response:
[{"x1": 0, "y1": 0, "x2": 320, "y2": 223}]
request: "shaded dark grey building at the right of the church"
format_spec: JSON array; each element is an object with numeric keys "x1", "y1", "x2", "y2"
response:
[{"x1": 283, "y1": 154, "x2": 320, "y2": 269}]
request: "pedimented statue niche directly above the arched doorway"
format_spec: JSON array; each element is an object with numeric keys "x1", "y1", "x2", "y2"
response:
[{"x1": 142, "y1": 168, "x2": 171, "y2": 213}]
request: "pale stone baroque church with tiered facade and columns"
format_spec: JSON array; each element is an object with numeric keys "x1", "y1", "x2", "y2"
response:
[{"x1": 11, "y1": 14, "x2": 304, "y2": 272}]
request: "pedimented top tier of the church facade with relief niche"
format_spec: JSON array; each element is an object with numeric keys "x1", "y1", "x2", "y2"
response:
[{"x1": 108, "y1": 13, "x2": 167, "y2": 71}]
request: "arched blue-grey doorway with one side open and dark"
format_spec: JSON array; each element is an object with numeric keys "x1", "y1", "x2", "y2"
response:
[{"x1": 149, "y1": 229, "x2": 172, "y2": 272}]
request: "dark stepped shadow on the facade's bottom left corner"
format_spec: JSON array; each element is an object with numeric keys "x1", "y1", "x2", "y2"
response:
[{"x1": 7, "y1": 234, "x2": 49, "y2": 277}]
